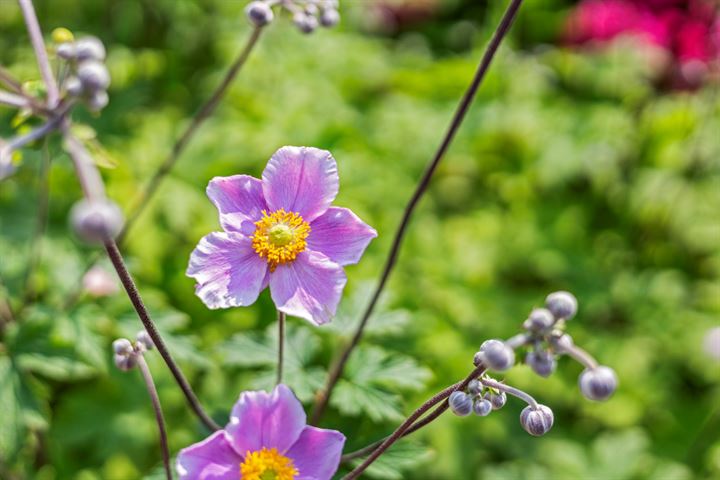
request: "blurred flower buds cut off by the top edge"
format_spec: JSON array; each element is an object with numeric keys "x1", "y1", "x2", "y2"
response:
[{"x1": 245, "y1": 0, "x2": 340, "y2": 33}]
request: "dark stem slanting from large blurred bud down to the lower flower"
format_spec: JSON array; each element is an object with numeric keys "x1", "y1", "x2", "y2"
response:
[{"x1": 105, "y1": 240, "x2": 220, "y2": 430}]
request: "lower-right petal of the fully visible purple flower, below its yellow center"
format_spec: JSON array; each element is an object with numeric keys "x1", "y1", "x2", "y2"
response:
[{"x1": 270, "y1": 250, "x2": 347, "y2": 325}]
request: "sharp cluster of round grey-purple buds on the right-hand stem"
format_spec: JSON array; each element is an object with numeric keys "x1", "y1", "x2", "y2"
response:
[{"x1": 458, "y1": 292, "x2": 618, "y2": 436}]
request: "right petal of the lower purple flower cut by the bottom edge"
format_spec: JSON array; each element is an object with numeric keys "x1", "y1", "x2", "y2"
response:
[{"x1": 287, "y1": 426, "x2": 345, "y2": 480}]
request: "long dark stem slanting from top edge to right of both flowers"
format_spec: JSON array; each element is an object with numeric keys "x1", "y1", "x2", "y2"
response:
[{"x1": 311, "y1": 0, "x2": 522, "y2": 424}]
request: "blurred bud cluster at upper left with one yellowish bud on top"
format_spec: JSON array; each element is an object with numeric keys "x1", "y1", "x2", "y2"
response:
[{"x1": 53, "y1": 29, "x2": 110, "y2": 112}]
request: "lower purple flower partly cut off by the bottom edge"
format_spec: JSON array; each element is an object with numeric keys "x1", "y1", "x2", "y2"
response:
[{"x1": 177, "y1": 385, "x2": 345, "y2": 480}]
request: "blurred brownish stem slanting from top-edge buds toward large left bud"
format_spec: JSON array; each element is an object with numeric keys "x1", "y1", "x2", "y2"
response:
[{"x1": 117, "y1": 27, "x2": 263, "y2": 245}]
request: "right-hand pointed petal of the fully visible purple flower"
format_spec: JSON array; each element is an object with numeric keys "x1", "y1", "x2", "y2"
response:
[{"x1": 307, "y1": 207, "x2": 377, "y2": 265}]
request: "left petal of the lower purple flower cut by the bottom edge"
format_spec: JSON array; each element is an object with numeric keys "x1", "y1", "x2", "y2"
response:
[{"x1": 175, "y1": 430, "x2": 242, "y2": 480}]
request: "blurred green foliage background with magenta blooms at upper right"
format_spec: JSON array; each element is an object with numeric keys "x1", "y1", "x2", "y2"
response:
[{"x1": 0, "y1": 0, "x2": 720, "y2": 480}]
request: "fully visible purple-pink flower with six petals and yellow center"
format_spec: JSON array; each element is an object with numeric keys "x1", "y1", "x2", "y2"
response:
[{"x1": 187, "y1": 147, "x2": 377, "y2": 325}]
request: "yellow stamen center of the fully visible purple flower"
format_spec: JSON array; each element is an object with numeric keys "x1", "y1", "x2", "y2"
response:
[{"x1": 252, "y1": 208, "x2": 310, "y2": 272}]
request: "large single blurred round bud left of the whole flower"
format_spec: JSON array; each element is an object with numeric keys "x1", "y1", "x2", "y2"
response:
[{"x1": 70, "y1": 200, "x2": 123, "y2": 243}]
